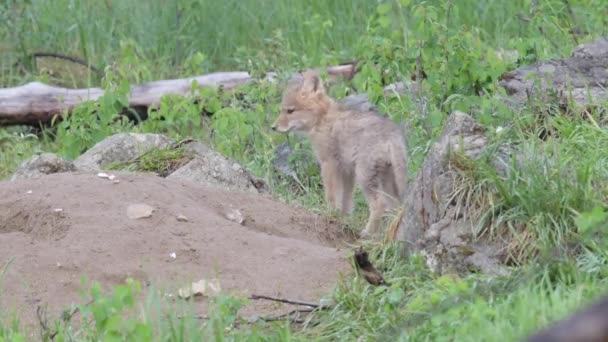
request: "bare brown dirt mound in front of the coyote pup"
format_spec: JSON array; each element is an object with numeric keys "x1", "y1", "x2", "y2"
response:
[{"x1": 0, "y1": 173, "x2": 348, "y2": 323}]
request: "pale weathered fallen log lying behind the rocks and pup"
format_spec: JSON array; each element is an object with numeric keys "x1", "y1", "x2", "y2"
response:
[{"x1": 0, "y1": 63, "x2": 355, "y2": 126}]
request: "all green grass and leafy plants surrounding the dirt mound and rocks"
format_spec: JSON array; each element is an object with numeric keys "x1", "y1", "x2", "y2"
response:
[{"x1": 0, "y1": 0, "x2": 608, "y2": 341}]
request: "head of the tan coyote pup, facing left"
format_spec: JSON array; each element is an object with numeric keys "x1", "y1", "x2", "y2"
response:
[{"x1": 272, "y1": 71, "x2": 331, "y2": 133}]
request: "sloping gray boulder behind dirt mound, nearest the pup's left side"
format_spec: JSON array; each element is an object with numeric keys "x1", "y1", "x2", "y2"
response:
[{"x1": 167, "y1": 142, "x2": 269, "y2": 193}]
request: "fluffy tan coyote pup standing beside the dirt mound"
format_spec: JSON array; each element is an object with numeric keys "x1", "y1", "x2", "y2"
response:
[{"x1": 272, "y1": 72, "x2": 407, "y2": 237}]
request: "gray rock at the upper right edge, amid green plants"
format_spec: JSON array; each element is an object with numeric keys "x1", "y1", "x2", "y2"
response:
[{"x1": 499, "y1": 37, "x2": 608, "y2": 106}]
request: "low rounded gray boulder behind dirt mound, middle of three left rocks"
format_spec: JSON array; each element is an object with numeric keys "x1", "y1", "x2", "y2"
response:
[{"x1": 74, "y1": 133, "x2": 172, "y2": 171}]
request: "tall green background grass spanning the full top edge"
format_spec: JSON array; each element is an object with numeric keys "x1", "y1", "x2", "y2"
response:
[{"x1": 0, "y1": 0, "x2": 608, "y2": 87}]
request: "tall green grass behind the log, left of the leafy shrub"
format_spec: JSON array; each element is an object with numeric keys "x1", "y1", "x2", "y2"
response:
[{"x1": 0, "y1": 0, "x2": 376, "y2": 86}]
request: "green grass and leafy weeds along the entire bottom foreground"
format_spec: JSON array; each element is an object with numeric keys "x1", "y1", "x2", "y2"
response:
[{"x1": 0, "y1": 245, "x2": 608, "y2": 341}]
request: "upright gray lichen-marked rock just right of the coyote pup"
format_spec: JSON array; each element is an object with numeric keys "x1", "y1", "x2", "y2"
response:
[{"x1": 397, "y1": 112, "x2": 505, "y2": 274}]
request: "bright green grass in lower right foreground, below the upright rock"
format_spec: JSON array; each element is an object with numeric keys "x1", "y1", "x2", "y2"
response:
[{"x1": 306, "y1": 242, "x2": 608, "y2": 341}]
